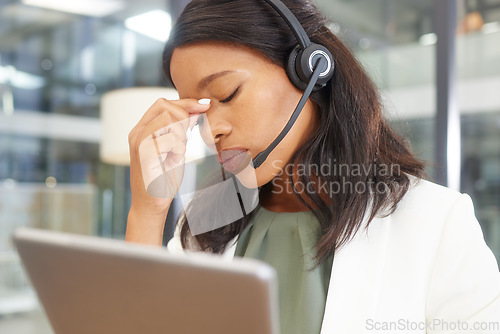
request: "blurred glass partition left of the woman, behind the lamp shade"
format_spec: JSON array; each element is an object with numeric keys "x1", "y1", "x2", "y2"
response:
[{"x1": 0, "y1": 0, "x2": 169, "y2": 334}]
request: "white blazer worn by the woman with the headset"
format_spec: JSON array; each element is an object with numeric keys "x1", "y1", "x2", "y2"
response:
[{"x1": 167, "y1": 177, "x2": 500, "y2": 334}]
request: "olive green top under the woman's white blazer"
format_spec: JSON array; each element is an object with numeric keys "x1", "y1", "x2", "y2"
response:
[{"x1": 235, "y1": 206, "x2": 333, "y2": 334}]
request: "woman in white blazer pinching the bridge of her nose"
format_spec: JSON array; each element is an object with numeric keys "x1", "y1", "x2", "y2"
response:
[{"x1": 126, "y1": 0, "x2": 500, "y2": 334}]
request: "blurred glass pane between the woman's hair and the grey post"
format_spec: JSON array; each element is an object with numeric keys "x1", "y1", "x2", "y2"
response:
[{"x1": 318, "y1": 0, "x2": 436, "y2": 176}]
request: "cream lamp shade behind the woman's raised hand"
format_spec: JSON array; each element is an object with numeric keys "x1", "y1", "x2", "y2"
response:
[{"x1": 100, "y1": 87, "x2": 179, "y2": 165}]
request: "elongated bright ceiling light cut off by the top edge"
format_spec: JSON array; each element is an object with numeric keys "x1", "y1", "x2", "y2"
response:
[{"x1": 22, "y1": 0, "x2": 125, "y2": 17}]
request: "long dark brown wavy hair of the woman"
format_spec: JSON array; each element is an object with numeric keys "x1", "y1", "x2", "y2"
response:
[{"x1": 163, "y1": 0, "x2": 425, "y2": 264}]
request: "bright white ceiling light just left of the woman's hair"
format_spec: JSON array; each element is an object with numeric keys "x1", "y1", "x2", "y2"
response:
[{"x1": 125, "y1": 9, "x2": 172, "y2": 42}]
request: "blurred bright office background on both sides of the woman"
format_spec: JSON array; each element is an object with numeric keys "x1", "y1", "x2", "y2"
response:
[{"x1": 0, "y1": 0, "x2": 500, "y2": 334}]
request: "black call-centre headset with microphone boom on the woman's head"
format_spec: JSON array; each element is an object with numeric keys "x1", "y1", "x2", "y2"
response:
[{"x1": 252, "y1": 0, "x2": 335, "y2": 169}]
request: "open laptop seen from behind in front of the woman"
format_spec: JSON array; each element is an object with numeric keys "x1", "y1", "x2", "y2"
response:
[{"x1": 13, "y1": 228, "x2": 279, "y2": 334}]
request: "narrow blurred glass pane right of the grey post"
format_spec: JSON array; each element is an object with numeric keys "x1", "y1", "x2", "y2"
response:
[{"x1": 457, "y1": 0, "x2": 500, "y2": 259}]
